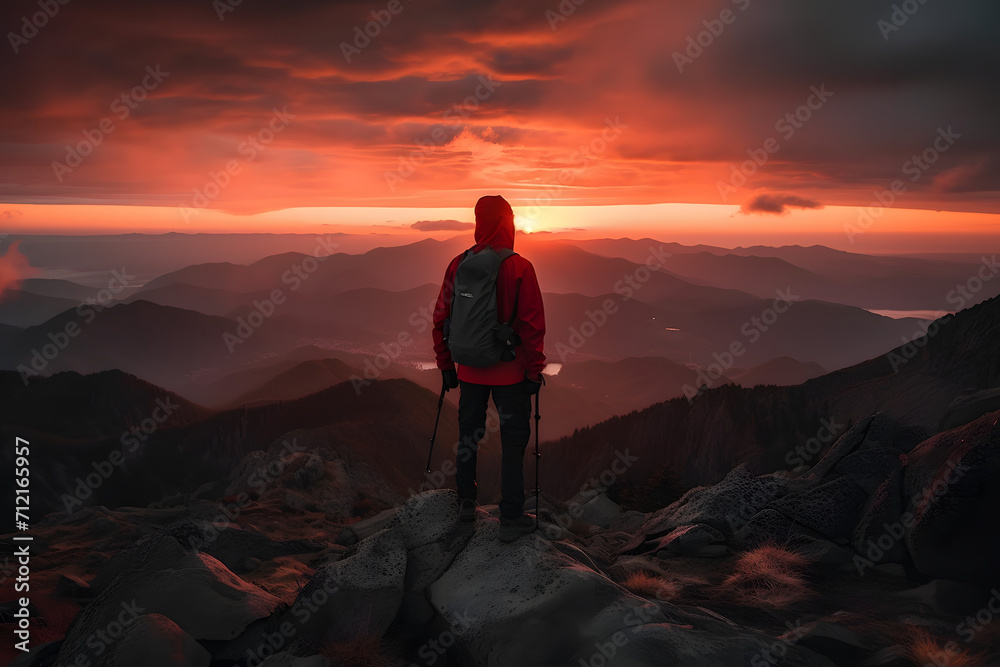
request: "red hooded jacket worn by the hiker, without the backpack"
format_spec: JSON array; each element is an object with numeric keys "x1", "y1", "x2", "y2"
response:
[{"x1": 433, "y1": 197, "x2": 545, "y2": 385}]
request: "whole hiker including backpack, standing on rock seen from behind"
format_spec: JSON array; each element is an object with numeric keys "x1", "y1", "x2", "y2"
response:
[{"x1": 434, "y1": 195, "x2": 545, "y2": 542}]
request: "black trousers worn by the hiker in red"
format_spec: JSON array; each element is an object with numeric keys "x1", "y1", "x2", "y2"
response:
[{"x1": 455, "y1": 382, "x2": 531, "y2": 519}]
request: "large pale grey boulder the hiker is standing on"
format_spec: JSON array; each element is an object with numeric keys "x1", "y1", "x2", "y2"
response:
[{"x1": 428, "y1": 520, "x2": 833, "y2": 667}]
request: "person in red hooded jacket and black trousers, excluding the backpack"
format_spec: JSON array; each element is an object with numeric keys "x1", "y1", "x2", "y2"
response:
[{"x1": 434, "y1": 195, "x2": 545, "y2": 542}]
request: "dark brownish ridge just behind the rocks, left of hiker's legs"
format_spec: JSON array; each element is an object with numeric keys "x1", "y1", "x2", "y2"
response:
[{"x1": 3, "y1": 377, "x2": 499, "y2": 516}]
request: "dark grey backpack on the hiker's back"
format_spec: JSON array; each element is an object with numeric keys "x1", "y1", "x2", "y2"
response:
[{"x1": 445, "y1": 246, "x2": 521, "y2": 367}]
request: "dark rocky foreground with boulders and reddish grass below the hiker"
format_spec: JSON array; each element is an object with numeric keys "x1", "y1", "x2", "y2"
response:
[{"x1": 0, "y1": 412, "x2": 1000, "y2": 667}]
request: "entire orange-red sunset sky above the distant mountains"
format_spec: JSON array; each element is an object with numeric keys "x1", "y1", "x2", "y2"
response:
[{"x1": 0, "y1": 0, "x2": 1000, "y2": 250}]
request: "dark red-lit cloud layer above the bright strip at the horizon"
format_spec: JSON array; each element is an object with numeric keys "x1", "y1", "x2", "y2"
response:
[{"x1": 0, "y1": 0, "x2": 1000, "y2": 205}]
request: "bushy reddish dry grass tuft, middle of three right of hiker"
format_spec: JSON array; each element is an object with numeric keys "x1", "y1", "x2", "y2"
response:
[{"x1": 723, "y1": 544, "x2": 813, "y2": 609}]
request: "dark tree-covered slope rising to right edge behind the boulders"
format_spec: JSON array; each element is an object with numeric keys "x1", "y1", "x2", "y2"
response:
[{"x1": 547, "y1": 298, "x2": 1000, "y2": 495}]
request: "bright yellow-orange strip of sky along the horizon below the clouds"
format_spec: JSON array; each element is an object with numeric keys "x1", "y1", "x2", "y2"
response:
[{"x1": 0, "y1": 198, "x2": 1000, "y2": 252}]
